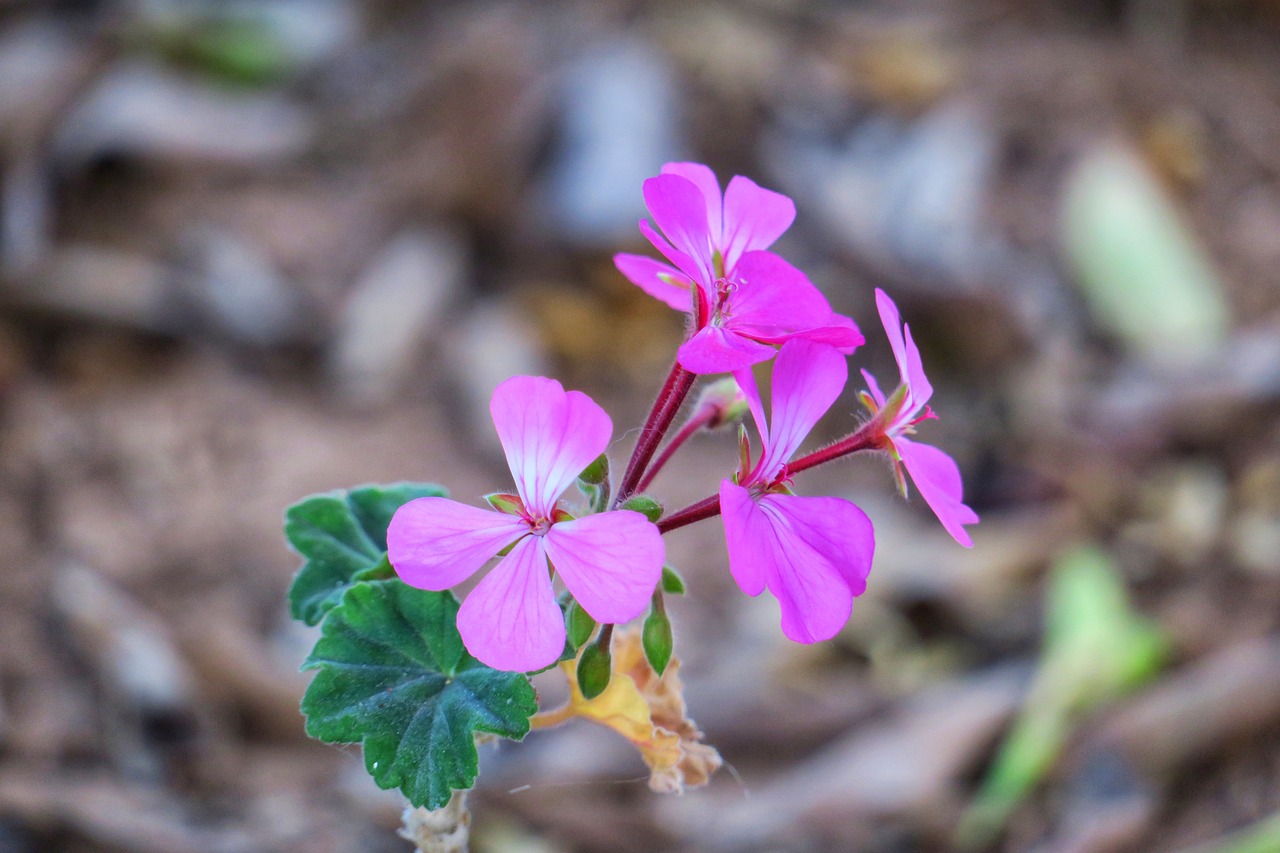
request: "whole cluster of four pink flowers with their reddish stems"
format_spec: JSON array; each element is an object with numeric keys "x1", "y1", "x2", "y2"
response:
[{"x1": 388, "y1": 163, "x2": 978, "y2": 671}]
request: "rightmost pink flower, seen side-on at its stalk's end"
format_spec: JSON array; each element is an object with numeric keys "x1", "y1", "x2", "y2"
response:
[{"x1": 863, "y1": 288, "x2": 978, "y2": 548}]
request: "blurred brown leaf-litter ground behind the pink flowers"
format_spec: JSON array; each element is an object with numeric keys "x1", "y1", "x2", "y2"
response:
[{"x1": 0, "y1": 0, "x2": 1280, "y2": 853}]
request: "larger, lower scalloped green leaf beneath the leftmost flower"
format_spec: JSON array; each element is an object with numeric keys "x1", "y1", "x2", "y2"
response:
[{"x1": 302, "y1": 580, "x2": 538, "y2": 809}]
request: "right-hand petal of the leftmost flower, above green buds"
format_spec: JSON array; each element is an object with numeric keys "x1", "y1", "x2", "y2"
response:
[{"x1": 545, "y1": 510, "x2": 666, "y2": 622}]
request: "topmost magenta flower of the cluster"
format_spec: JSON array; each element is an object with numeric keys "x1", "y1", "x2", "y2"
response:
[{"x1": 613, "y1": 163, "x2": 863, "y2": 374}]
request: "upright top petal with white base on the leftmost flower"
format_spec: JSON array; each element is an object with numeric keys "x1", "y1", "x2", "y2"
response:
[{"x1": 489, "y1": 377, "x2": 613, "y2": 517}]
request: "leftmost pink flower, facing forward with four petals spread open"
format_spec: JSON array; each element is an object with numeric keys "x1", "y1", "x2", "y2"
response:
[{"x1": 387, "y1": 377, "x2": 664, "y2": 672}]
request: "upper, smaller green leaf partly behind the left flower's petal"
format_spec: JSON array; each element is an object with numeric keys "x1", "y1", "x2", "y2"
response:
[{"x1": 284, "y1": 483, "x2": 445, "y2": 625}]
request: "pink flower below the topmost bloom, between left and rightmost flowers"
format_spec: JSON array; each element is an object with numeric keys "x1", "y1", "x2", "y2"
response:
[{"x1": 719, "y1": 339, "x2": 876, "y2": 643}]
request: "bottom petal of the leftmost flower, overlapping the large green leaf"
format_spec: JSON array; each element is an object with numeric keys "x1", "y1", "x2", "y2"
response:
[{"x1": 458, "y1": 537, "x2": 564, "y2": 672}]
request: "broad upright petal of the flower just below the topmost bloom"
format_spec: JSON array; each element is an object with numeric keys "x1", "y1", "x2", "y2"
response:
[{"x1": 760, "y1": 339, "x2": 849, "y2": 476}]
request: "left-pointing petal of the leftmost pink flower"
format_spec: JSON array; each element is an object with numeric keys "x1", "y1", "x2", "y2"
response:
[{"x1": 387, "y1": 497, "x2": 529, "y2": 589}]
